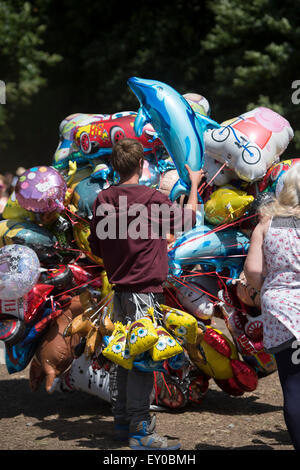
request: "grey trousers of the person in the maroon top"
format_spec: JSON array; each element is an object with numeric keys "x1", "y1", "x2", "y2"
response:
[{"x1": 111, "y1": 292, "x2": 164, "y2": 430}]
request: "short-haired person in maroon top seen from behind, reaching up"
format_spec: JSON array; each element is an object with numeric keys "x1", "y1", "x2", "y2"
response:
[{"x1": 89, "y1": 139, "x2": 204, "y2": 450}]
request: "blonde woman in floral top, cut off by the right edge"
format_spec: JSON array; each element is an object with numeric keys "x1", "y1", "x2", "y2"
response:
[{"x1": 244, "y1": 163, "x2": 300, "y2": 450}]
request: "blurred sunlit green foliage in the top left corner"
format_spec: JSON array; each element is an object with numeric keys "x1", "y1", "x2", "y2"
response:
[{"x1": 0, "y1": 0, "x2": 60, "y2": 147}]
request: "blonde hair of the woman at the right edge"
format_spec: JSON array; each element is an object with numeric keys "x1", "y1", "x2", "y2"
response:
[{"x1": 259, "y1": 162, "x2": 300, "y2": 218}]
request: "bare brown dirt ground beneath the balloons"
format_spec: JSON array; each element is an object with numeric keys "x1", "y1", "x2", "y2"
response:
[{"x1": 0, "y1": 365, "x2": 293, "y2": 450}]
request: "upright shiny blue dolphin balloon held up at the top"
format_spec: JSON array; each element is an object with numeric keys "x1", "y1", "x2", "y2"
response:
[{"x1": 127, "y1": 77, "x2": 220, "y2": 200}]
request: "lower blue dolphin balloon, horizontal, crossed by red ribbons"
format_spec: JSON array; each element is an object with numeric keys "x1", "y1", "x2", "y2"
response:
[{"x1": 168, "y1": 225, "x2": 249, "y2": 279}]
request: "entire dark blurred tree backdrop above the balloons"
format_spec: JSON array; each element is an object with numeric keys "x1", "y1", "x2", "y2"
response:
[{"x1": 0, "y1": 0, "x2": 300, "y2": 173}]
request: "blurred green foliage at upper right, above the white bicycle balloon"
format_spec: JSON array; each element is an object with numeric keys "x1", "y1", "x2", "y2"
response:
[{"x1": 202, "y1": 0, "x2": 300, "y2": 150}]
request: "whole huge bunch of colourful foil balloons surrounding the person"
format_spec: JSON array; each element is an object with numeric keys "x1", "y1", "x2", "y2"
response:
[{"x1": 0, "y1": 77, "x2": 299, "y2": 408}]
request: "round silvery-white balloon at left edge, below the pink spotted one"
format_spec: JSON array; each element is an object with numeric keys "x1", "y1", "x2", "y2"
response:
[{"x1": 0, "y1": 245, "x2": 40, "y2": 299}]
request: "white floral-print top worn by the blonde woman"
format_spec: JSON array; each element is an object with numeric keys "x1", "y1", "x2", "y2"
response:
[{"x1": 261, "y1": 217, "x2": 300, "y2": 353}]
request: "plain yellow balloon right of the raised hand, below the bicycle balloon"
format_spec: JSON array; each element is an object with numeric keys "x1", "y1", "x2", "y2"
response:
[{"x1": 204, "y1": 185, "x2": 254, "y2": 225}]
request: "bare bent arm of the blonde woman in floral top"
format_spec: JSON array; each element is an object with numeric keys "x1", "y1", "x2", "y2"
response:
[{"x1": 244, "y1": 221, "x2": 268, "y2": 292}]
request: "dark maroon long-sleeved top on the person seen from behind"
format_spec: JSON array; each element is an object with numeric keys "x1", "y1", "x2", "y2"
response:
[{"x1": 89, "y1": 184, "x2": 196, "y2": 292}]
